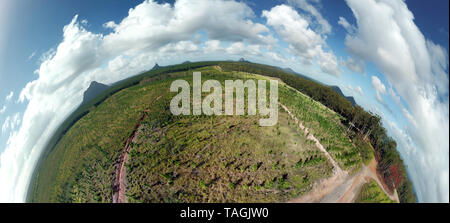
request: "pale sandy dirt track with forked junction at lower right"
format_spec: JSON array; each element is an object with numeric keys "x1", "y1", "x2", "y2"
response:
[{"x1": 280, "y1": 104, "x2": 399, "y2": 203}]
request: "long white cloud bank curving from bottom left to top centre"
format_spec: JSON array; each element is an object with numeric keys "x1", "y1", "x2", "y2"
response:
[{"x1": 0, "y1": 0, "x2": 286, "y2": 202}]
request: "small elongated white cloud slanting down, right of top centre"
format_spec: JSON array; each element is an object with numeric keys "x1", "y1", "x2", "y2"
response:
[{"x1": 262, "y1": 5, "x2": 340, "y2": 76}]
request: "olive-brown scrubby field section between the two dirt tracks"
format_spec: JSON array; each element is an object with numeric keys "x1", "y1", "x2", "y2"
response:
[{"x1": 127, "y1": 71, "x2": 332, "y2": 202}]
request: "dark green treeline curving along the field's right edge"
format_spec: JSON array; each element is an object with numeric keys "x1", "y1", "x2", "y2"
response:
[{"x1": 219, "y1": 62, "x2": 415, "y2": 202}]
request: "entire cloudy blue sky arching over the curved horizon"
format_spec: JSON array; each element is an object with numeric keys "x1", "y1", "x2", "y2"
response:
[{"x1": 0, "y1": 0, "x2": 449, "y2": 202}]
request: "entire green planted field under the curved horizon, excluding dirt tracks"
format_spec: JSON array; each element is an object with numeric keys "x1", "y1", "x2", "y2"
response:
[{"x1": 29, "y1": 66, "x2": 376, "y2": 202}]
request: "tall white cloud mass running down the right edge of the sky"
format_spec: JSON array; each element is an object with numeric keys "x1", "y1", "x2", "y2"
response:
[{"x1": 345, "y1": 0, "x2": 449, "y2": 202}]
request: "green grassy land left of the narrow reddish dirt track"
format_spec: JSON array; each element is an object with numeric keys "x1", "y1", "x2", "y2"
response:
[{"x1": 32, "y1": 78, "x2": 169, "y2": 202}]
